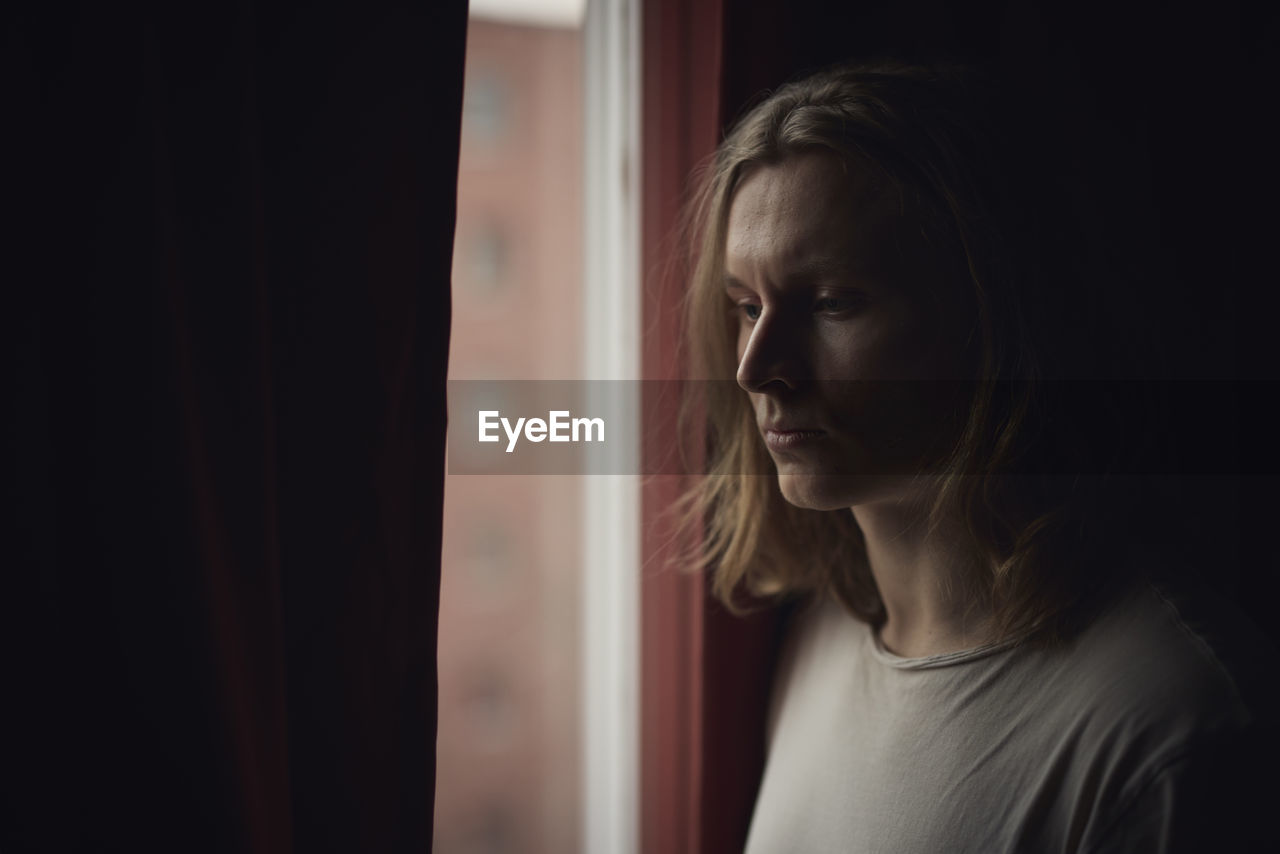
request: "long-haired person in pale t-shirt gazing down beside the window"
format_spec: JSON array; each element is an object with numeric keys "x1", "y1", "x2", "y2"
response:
[{"x1": 684, "y1": 61, "x2": 1276, "y2": 854}]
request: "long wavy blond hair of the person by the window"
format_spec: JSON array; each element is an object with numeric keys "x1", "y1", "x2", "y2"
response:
[{"x1": 681, "y1": 63, "x2": 1131, "y2": 638}]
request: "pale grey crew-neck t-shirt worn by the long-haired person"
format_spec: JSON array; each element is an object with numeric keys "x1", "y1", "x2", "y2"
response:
[{"x1": 746, "y1": 584, "x2": 1280, "y2": 854}]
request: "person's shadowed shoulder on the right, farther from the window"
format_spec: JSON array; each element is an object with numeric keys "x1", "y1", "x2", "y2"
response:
[{"x1": 1053, "y1": 577, "x2": 1280, "y2": 851}]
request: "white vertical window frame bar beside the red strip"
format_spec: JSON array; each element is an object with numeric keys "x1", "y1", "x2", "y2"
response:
[{"x1": 581, "y1": 0, "x2": 641, "y2": 854}]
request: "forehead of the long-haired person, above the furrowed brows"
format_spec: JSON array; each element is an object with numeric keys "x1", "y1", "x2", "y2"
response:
[{"x1": 724, "y1": 152, "x2": 905, "y2": 277}]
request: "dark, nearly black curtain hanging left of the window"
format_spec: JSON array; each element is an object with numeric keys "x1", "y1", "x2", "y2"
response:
[{"x1": 0, "y1": 0, "x2": 466, "y2": 854}]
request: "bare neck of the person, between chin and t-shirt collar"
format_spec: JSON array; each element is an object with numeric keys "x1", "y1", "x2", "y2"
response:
[{"x1": 852, "y1": 486, "x2": 991, "y2": 658}]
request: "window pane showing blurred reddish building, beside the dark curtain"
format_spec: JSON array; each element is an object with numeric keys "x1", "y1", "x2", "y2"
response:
[{"x1": 435, "y1": 3, "x2": 584, "y2": 854}]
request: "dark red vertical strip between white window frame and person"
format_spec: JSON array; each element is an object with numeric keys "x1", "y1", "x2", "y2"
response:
[{"x1": 640, "y1": 0, "x2": 778, "y2": 854}]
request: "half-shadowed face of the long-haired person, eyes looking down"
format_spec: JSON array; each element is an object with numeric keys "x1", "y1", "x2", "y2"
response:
[{"x1": 724, "y1": 152, "x2": 973, "y2": 510}]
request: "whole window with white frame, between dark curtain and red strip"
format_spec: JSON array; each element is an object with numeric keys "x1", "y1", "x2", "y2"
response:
[{"x1": 435, "y1": 0, "x2": 640, "y2": 854}]
